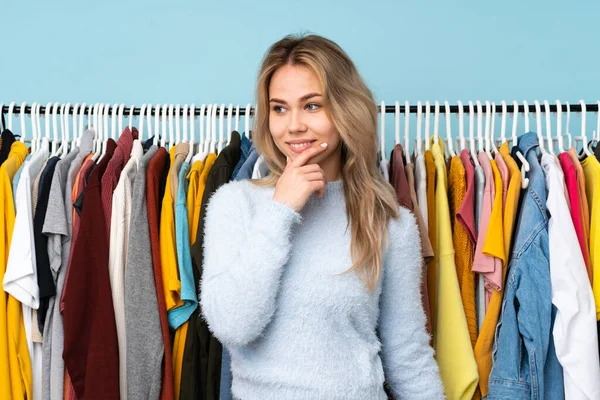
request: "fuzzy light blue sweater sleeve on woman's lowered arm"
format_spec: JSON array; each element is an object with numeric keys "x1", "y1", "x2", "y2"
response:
[{"x1": 378, "y1": 207, "x2": 444, "y2": 400}]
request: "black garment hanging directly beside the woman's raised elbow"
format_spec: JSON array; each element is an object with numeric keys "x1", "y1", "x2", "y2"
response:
[{"x1": 180, "y1": 131, "x2": 241, "y2": 400}]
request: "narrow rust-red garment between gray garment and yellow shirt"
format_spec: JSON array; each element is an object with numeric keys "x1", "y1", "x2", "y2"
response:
[{"x1": 146, "y1": 147, "x2": 175, "y2": 400}]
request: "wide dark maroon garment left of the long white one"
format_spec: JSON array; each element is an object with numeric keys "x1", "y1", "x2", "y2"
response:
[{"x1": 63, "y1": 140, "x2": 119, "y2": 400}]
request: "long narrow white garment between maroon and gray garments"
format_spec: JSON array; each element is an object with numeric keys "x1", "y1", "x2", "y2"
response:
[{"x1": 108, "y1": 139, "x2": 144, "y2": 400}]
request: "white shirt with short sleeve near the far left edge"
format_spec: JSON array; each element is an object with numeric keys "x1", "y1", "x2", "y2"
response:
[{"x1": 2, "y1": 138, "x2": 49, "y2": 399}]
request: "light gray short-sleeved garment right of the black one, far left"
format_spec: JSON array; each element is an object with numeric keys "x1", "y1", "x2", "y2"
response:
[{"x1": 42, "y1": 130, "x2": 94, "y2": 400}]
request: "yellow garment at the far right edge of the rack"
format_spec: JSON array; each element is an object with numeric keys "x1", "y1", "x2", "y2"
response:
[{"x1": 581, "y1": 155, "x2": 600, "y2": 320}]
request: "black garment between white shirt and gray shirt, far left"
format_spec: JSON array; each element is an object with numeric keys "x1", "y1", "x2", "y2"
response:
[{"x1": 33, "y1": 157, "x2": 60, "y2": 332}]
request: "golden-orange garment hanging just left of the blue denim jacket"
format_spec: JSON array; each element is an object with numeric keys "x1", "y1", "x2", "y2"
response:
[{"x1": 475, "y1": 143, "x2": 521, "y2": 396}]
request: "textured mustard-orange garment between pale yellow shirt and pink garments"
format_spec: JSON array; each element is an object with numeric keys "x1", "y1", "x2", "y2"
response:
[{"x1": 448, "y1": 156, "x2": 477, "y2": 347}]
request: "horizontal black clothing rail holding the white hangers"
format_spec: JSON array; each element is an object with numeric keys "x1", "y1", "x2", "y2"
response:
[{"x1": 1, "y1": 103, "x2": 599, "y2": 116}]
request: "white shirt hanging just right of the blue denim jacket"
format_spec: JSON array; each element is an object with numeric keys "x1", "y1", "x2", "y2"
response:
[{"x1": 541, "y1": 154, "x2": 600, "y2": 400}]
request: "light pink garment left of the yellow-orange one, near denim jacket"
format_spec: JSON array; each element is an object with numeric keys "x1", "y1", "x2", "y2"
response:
[{"x1": 472, "y1": 152, "x2": 502, "y2": 309}]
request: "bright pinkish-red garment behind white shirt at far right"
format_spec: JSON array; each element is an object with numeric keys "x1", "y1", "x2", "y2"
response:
[{"x1": 558, "y1": 152, "x2": 592, "y2": 282}]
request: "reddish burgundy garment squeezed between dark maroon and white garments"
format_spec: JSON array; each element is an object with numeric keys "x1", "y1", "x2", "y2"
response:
[{"x1": 101, "y1": 127, "x2": 138, "y2": 239}]
